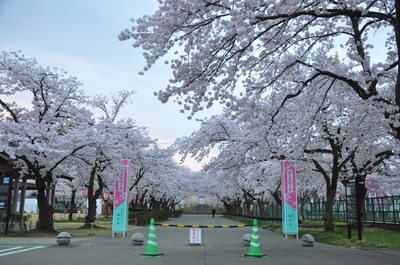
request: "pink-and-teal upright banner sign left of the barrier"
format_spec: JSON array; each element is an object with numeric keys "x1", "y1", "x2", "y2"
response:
[{"x1": 112, "y1": 159, "x2": 130, "y2": 237}]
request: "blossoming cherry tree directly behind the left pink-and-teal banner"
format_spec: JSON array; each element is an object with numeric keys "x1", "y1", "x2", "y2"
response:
[{"x1": 75, "y1": 91, "x2": 155, "y2": 224}]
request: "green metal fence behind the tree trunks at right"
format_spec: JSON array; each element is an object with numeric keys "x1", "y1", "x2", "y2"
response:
[{"x1": 305, "y1": 196, "x2": 400, "y2": 224}]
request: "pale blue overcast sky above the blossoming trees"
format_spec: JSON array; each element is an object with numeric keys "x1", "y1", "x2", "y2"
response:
[{"x1": 0, "y1": 0, "x2": 219, "y2": 169}]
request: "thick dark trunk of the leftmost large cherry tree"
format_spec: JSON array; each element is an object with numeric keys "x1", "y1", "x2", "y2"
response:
[{"x1": 36, "y1": 177, "x2": 55, "y2": 232}]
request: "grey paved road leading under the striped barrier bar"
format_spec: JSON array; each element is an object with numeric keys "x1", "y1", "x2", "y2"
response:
[{"x1": 0, "y1": 212, "x2": 400, "y2": 265}]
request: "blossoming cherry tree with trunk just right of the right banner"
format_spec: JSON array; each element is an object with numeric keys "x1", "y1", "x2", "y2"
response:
[{"x1": 247, "y1": 79, "x2": 398, "y2": 230}]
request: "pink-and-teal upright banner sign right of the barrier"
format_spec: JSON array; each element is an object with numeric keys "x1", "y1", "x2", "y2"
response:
[{"x1": 281, "y1": 161, "x2": 299, "y2": 238}]
